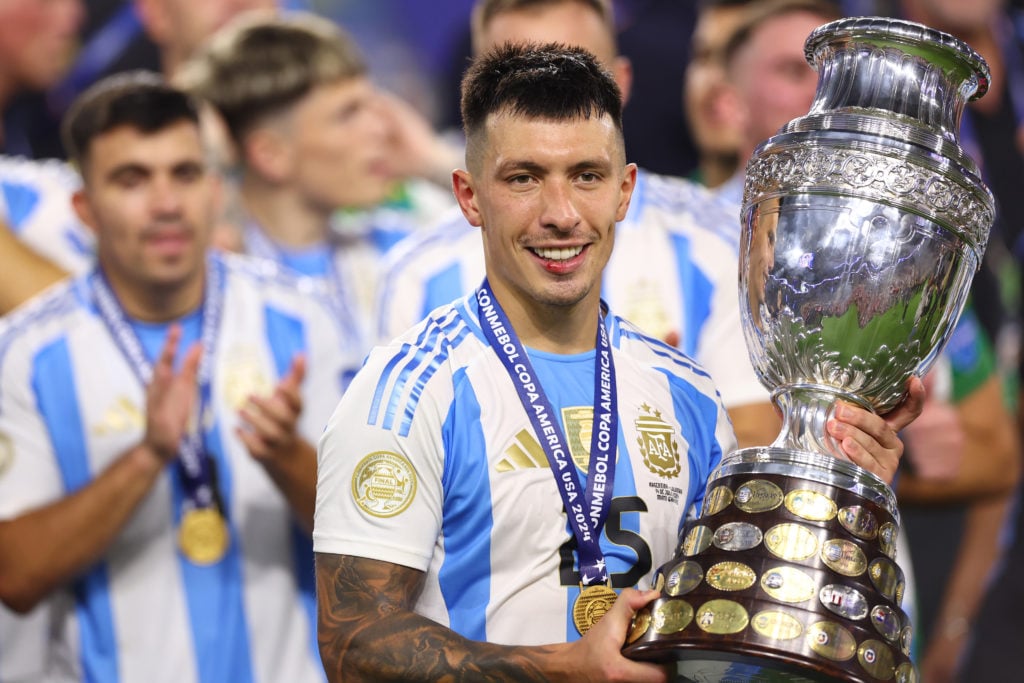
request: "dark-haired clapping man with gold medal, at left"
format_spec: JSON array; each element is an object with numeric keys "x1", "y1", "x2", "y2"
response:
[{"x1": 0, "y1": 74, "x2": 361, "y2": 683}]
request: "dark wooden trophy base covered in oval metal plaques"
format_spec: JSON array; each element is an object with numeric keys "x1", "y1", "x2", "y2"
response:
[{"x1": 623, "y1": 447, "x2": 918, "y2": 683}]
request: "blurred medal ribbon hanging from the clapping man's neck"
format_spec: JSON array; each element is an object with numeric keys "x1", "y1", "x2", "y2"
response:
[{"x1": 89, "y1": 259, "x2": 224, "y2": 513}]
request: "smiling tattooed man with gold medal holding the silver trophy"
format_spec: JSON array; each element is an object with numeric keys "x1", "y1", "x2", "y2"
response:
[{"x1": 313, "y1": 44, "x2": 920, "y2": 683}]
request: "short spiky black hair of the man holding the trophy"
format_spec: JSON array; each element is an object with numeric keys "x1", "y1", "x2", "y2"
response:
[{"x1": 462, "y1": 43, "x2": 623, "y2": 164}]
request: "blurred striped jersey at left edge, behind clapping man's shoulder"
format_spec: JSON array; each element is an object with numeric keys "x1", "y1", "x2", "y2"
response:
[{"x1": 0, "y1": 155, "x2": 95, "y2": 274}]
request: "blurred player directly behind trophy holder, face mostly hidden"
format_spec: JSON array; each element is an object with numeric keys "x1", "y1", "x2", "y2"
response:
[{"x1": 376, "y1": 0, "x2": 779, "y2": 445}]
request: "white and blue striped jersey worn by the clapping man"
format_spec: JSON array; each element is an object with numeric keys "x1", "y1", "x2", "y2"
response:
[{"x1": 0, "y1": 256, "x2": 361, "y2": 683}]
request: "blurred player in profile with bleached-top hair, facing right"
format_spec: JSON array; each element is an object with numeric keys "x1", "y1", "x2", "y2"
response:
[{"x1": 179, "y1": 12, "x2": 396, "y2": 348}]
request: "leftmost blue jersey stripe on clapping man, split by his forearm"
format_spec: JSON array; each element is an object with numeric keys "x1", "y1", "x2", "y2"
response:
[{"x1": 32, "y1": 337, "x2": 121, "y2": 683}]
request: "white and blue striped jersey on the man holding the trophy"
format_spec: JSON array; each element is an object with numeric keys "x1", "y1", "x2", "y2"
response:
[{"x1": 313, "y1": 295, "x2": 735, "y2": 644}]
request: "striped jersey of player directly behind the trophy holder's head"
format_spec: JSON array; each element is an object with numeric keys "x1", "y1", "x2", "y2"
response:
[{"x1": 375, "y1": 171, "x2": 768, "y2": 408}]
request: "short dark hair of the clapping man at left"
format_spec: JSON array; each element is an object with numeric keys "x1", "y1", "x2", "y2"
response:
[{"x1": 60, "y1": 71, "x2": 199, "y2": 171}]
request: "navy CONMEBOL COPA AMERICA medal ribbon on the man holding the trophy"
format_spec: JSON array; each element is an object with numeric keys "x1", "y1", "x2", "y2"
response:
[{"x1": 476, "y1": 279, "x2": 618, "y2": 586}]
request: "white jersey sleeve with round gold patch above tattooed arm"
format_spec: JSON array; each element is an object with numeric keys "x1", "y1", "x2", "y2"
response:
[{"x1": 313, "y1": 346, "x2": 451, "y2": 571}]
